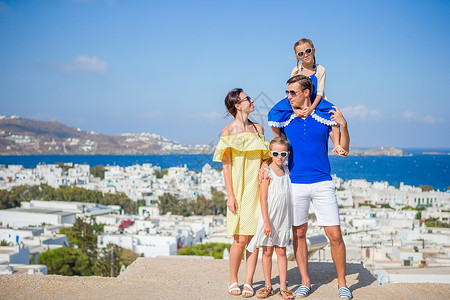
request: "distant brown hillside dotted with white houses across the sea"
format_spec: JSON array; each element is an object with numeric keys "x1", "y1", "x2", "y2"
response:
[{"x1": 0, "y1": 115, "x2": 214, "y2": 155}]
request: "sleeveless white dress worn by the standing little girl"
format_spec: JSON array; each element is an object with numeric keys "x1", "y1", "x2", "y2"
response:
[{"x1": 247, "y1": 166, "x2": 292, "y2": 252}]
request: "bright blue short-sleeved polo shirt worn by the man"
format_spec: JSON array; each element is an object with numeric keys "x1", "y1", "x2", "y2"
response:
[{"x1": 284, "y1": 112, "x2": 331, "y2": 184}]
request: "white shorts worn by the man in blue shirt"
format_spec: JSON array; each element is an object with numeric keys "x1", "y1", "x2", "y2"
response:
[{"x1": 291, "y1": 180, "x2": 341, "y2": 226}]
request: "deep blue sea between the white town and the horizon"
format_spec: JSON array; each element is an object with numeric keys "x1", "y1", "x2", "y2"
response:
[{"x1": 0, "y1": 149, "x2": 450, "y2": 191}]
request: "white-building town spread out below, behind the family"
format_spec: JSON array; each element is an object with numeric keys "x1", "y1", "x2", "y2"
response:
[{"x1": 0, "y1": 163, "x2": 450, "y2": 284}]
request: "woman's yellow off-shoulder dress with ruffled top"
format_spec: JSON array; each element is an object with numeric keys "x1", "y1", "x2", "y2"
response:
[{"x1": 213, "y1": 132, "x2": 269, "y2": 237}]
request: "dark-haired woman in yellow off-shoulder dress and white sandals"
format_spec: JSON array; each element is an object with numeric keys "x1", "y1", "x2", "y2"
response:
[{"x1": 213, "y1": 89, "x2": 269, "y2": 297}]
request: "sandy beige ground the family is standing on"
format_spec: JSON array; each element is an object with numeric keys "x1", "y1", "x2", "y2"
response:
[{"x1": 0, "y1": 256, "x2": 450, "y2": 300}]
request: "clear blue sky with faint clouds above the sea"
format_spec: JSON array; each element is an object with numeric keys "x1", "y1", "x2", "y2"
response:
[{"x1": 0, "y1": 0, "x2": 450, "y2": 148}]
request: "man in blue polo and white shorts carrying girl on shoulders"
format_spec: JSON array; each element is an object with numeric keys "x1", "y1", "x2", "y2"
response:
[{"x1": 272, "y1": 75, "x2": 352, "y2": 299}]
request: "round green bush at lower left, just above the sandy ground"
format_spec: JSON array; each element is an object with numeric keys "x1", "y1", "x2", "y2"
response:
[{"x1": 39, "y1": 247, "x2": 95, "y2": 276}]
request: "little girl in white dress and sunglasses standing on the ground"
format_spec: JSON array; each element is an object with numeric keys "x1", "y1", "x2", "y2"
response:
[{"x1": 247, "y1": 138, "x2": 294, "y2": 299}]
